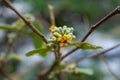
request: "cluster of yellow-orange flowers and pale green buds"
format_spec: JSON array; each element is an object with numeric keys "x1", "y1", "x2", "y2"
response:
[{"x1": 49, "y1": 25, "x2": 75, "y2": 44}]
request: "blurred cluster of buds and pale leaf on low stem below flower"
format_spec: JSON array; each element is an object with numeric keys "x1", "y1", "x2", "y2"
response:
[{"x1": 49, "y1": 63, "x2": 94, "y2": 79}]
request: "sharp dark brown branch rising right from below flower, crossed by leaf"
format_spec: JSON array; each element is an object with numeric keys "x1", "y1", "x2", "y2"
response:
[{"x1": 62, "y1": 6, "x2": 120, "y2": 60}]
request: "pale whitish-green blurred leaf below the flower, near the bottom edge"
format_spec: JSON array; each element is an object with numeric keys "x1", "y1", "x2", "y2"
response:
[{"x1": 75, "y1": 67, "x2": 93, "y2": 75}]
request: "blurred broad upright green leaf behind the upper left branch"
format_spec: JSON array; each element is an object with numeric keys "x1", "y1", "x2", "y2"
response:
[{"x1": 32, "y1": 21, "x2": 44, "y2": 48}]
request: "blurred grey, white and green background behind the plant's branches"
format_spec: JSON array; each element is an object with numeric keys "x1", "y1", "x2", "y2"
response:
[{"x1": 0, "y1": 0, "x2": 120, "y2": 80}]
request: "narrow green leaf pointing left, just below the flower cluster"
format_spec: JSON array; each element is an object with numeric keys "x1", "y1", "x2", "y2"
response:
[{"x1": 26, "y1": 48, "x2": 48, "y2": 57}]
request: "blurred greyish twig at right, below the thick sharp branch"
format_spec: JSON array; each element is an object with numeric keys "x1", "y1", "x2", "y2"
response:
[{"x1": 68, "y1": 44, "x2": 120, "y2": 64}]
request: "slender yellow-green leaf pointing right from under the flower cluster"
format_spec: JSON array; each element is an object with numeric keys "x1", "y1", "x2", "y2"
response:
[{"x1": 68, "y1": 42, "x2": 102, "y2": 50}]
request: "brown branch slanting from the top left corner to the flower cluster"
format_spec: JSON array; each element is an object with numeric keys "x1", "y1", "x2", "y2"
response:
[{"x1": 3, "y1": 0, "x2": 47, "y2": 43}]
